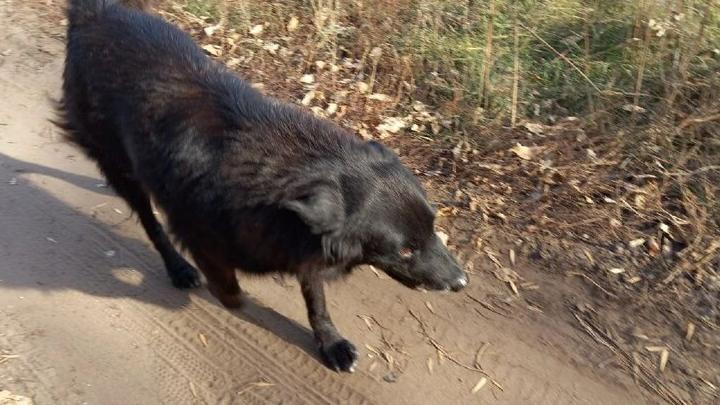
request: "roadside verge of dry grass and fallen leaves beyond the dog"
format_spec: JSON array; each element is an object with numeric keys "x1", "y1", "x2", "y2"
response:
[{"x1": 161, "y1": 0, "x2": 720, "y2": 403}]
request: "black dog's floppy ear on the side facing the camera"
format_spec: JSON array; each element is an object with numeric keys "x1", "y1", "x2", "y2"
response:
[{"x1": 282, "y1": 184, "x2": 345, "y2": 235}]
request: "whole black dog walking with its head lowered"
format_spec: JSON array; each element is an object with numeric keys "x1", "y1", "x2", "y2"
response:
[{"x1": 61, "y1": 0, "x2": 468, "y2": 371}]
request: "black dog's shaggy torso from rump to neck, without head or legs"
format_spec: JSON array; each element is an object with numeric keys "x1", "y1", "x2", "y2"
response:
[{"x1": 63, "y1": 1, "x2": 374, "y2": 272}]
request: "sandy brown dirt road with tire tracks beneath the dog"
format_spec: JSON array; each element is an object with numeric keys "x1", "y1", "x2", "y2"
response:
[{"x1": 0, "y1": 0, "x2": 648, "y2": 404}]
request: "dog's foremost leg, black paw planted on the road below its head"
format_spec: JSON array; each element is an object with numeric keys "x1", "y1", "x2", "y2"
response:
[{"x1": 298, "y1": 269, "x2": 358, "y2": 372}]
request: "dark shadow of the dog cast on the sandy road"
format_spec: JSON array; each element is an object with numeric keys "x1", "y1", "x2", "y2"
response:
[{"x1": 0, "y1": 154, "x2": 321, "y2": 362}]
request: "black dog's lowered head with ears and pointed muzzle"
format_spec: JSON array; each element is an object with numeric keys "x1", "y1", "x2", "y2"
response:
[{"x1": 285, "y1": 142, "x2": 468, "y2": 291}]
